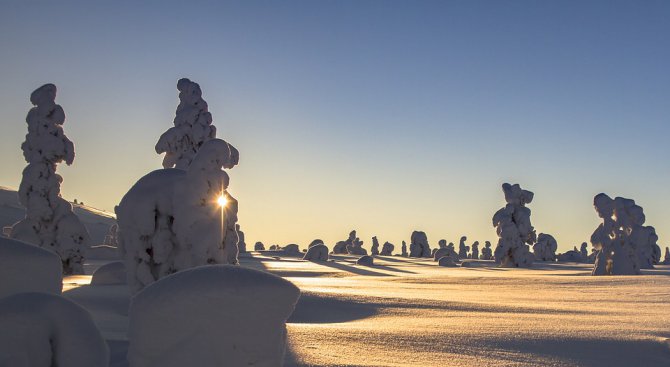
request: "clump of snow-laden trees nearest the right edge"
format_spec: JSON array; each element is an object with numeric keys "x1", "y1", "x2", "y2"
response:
[{"x1": 591, "y1": 193, "x2": 661, "y2": 275}]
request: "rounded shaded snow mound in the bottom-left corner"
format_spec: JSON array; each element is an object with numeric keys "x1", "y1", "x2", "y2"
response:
[{"x1": 0, "y1": 293, "x2": 109, "y2": 367}]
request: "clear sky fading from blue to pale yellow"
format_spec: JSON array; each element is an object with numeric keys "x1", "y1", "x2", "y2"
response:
[{"x1": 0, "y1": 0, "x2": 670, "y2": 250}]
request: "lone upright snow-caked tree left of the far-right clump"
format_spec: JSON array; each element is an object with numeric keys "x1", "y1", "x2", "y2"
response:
[{"x1": 493, "y1": 183, "x2": 535, "y2": 267}]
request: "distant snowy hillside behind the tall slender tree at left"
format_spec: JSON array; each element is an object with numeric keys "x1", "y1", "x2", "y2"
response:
[{"x1": 0, "y1": 186, "x2": 116, "y2": 246}]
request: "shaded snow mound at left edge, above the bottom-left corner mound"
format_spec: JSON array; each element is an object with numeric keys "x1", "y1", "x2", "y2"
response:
[{"x1": 0, "y1": 237, "x2": 63, "y2": 300}]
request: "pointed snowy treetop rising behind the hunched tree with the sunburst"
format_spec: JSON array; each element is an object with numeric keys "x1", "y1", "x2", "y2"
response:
[{"x1": 156, "y1": 78, "x2": 216, "y2": 169}]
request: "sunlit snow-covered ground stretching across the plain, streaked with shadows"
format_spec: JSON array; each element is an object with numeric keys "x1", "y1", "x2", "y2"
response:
[{"x1": 63, "y1": 252, "x2": 670, "y2": 366}]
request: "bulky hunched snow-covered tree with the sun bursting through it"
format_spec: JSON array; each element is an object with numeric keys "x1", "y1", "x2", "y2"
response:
[{"x1": 116, "y1": 139, "x2": 239, "y2": 292}]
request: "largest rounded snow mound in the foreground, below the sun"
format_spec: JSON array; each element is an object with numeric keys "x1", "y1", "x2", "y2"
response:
[{"x1": 128, "y1": 265, "x2": 300, "y2": 367}]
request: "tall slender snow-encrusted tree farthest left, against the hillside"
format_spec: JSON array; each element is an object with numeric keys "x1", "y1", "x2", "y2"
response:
[{"x1": 10, "y1": 84, "x2": 91, "y2": 274}]
